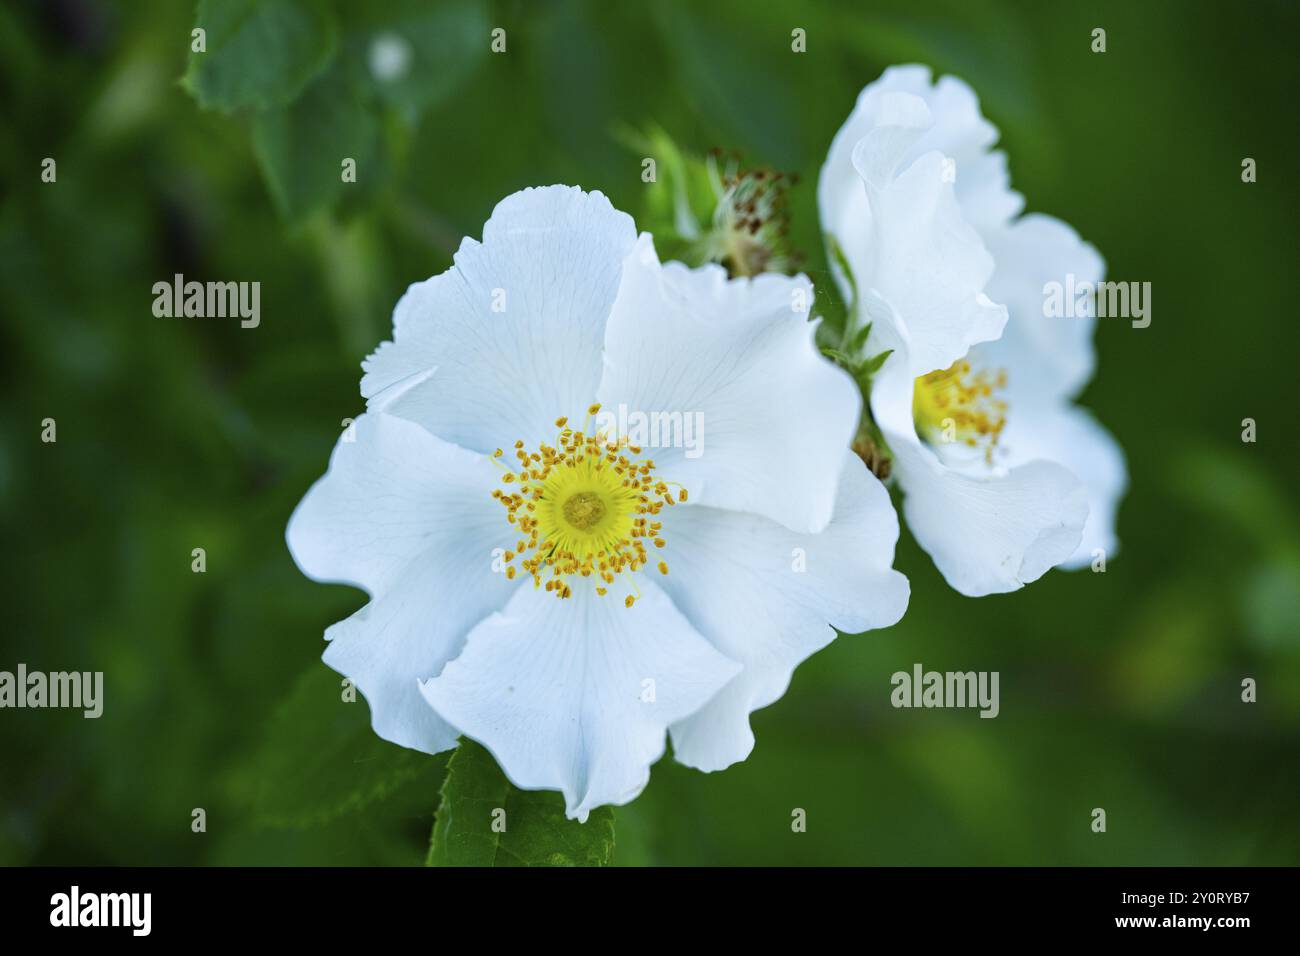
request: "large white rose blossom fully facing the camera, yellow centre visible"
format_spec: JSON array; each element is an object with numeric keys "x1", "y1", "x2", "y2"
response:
[{"x1": 287, "y1": 186, "x2": 907, "y2": 819}]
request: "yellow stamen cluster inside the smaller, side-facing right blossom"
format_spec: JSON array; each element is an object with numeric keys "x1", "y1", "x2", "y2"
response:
[{"x1": 913, "y1": 359, "x2": 1008, "y2": 463}]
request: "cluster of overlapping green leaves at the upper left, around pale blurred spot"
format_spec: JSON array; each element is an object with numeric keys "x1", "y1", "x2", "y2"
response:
[{"x1": 182, "y1": 0, "x2": 490, "y2": 222}]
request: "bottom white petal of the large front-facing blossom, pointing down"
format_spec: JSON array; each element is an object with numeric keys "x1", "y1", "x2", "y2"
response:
[{"x1": 421, "y1": 575, "x2": 740, "y2": 821}]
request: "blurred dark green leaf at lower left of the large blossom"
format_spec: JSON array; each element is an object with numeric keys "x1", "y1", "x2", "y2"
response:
[{"x1": 250, "y1": 663, "x2": 446, "y2": 827}]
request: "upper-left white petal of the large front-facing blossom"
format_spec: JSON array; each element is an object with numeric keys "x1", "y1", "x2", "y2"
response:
[{"x1": 361, "y1": 186, "x2": 636, "y2": 453}]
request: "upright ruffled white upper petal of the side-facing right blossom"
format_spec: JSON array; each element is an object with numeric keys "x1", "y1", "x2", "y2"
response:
[{"x1": 818, "y1": 66, "x2": 1023, "y2": 375}]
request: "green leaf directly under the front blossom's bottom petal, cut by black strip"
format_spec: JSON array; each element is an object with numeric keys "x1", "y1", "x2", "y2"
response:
[{"x1": 428, "y1": 739, "x2": 614, "y2": 866}]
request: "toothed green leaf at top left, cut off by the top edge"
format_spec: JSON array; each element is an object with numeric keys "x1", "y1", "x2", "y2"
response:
[{"x1": 182, "y1": 0, "x2": 338, "y2": 112}]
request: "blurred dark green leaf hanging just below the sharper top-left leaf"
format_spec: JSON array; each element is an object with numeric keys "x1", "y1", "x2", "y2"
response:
[{"x1": 252, "y1": 65, "x2": 380, "y2": 221}]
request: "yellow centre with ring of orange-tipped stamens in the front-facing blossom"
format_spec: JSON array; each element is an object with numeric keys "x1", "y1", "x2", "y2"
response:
[{"x1": 491, "y1": 405, "x2": 686, "y2": 607}]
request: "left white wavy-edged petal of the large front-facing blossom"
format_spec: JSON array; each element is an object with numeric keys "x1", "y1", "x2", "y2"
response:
[{"x1": 286, "y1": 415, "x2": 514, "y2": 753}]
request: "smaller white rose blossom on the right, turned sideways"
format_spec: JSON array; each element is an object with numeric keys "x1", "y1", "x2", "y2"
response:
[{"x1": 818, "y1": 66, "x2": 1126, "y2": 596}]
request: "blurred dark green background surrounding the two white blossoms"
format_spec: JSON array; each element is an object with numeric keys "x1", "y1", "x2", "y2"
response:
[{"x1": 0, "y1": 0, "x2": 1300, "y2": 865}]
